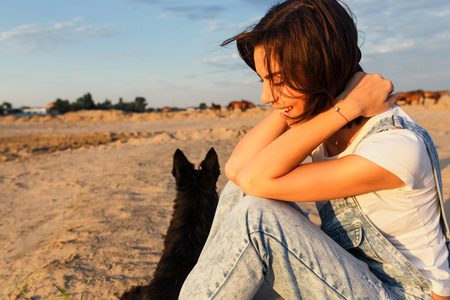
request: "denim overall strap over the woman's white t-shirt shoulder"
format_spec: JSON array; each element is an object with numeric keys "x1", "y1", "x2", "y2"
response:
[{"x1": 360, "y1": 115, "x2": 450, "y2": 242}]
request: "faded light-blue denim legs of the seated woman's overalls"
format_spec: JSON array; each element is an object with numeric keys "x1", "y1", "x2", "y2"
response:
[{"x1": 179, "y1": 182, "x2": 431, "y2": 300}]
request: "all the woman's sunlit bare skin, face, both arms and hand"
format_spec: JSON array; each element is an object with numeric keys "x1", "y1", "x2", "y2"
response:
[{"x1": 225, "y1": 47, "x2": 405, "y2": 202}]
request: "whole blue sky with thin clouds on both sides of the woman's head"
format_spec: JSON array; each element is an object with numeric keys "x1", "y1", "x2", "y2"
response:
[{"x1": 0, "y1": 0, "x2": 450, "y2": 108}]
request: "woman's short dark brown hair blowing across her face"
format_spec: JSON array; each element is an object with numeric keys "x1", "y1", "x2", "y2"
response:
[{"x1": 222, "y1": 0, "x2": 362, "y2": 122}]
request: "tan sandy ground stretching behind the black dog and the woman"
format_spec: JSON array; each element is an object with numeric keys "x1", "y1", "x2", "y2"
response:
[{"x1": 0, "y1": 97, "x2": 450, "y2": 299}]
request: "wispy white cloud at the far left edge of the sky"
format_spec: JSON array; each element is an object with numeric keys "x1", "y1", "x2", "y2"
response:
[{"x1": 0, "y1": 17, "x2": 116, "y2": 53}]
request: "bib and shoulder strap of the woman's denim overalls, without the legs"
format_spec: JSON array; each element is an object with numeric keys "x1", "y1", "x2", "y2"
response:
[{"x1": 319, "y1": 116, "x2": 450, "y2": 299}]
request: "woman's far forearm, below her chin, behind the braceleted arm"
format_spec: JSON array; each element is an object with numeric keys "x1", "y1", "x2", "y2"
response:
[{"x1": 225, "y1": 110, "x2": 288, "y2": 183}]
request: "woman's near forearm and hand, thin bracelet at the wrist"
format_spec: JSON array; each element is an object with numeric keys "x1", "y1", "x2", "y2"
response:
[{"x1": 236, "y1": 73, "x2": 398, "y2": 196}]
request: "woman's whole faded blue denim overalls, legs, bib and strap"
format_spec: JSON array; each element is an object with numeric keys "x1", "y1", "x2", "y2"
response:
[{"x1": 179, "y1": 117, "x2": 449, "y2": 300}]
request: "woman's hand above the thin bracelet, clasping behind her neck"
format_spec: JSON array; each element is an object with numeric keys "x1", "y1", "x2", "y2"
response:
[{"x1": 335, "y1": 72, "x2": 399, "y2": 118}]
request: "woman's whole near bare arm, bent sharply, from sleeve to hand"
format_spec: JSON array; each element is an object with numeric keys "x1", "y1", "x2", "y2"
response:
[{"x1": 236, "y1": 74, "x2": 404, "y2": 201}]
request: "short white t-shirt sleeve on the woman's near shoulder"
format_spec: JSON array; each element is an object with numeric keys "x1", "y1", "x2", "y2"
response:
[{"x1": 354, "y1": 129, "x2": 430, "y2": 189}]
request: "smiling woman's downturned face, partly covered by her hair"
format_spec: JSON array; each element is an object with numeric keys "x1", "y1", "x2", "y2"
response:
[{"x1": 254, "y1": 46, "x2": 305, "y2": 124}]
